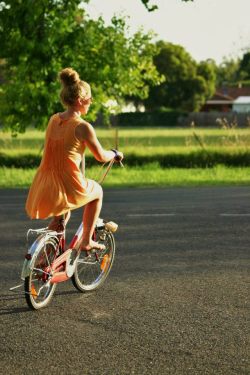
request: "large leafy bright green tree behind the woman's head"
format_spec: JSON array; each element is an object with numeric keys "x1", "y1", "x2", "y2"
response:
[{"x1": 0, "y1": 0, "x2": 160, "y2": 133}]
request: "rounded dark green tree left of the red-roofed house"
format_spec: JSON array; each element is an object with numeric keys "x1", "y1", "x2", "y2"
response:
[{"x1": 145, "y1": 41, "x2": 216, "y2": 111}]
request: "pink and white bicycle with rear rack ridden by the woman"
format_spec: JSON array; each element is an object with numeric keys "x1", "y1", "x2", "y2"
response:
[{"x1": 18, "y1": 160, "x2": 122, "y2": 310}]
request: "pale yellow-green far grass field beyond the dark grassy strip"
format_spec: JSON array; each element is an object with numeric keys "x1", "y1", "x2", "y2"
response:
[{"x1": 0, "y1": 128, "x2": 250, "y2": 155}]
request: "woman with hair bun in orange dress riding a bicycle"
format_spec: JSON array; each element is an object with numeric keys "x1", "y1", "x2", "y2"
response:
[{"x1": 26, "y1": 68, "x2": 123, "y2": 251}]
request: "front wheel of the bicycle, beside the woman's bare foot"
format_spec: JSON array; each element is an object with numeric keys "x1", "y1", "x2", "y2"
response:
[{"x1": 71, "y1": 229, "x2": 115, "y2": 292}]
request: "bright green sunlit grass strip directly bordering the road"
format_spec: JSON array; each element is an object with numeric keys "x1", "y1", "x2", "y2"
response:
[{"x1": 0, "y1": 163, "x2": 250, "y2": 188}]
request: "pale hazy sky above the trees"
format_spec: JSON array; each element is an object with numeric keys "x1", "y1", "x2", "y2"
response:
[{"x1": 87, "y1": 0, "x2": 250, "y2": 64}]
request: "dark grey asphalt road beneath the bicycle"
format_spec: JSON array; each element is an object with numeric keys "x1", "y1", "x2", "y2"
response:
[{"x1": 0, "y1": 187, "x2": 250, "y2": 375}]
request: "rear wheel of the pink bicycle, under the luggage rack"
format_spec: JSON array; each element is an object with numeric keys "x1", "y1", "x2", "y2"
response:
[{"x1": 24, "y1": 237, "x2": 59, "y2": 310}]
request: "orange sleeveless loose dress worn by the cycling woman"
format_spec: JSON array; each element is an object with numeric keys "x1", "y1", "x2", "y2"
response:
[{"x1": 25, "y1": 114, "x2": 101, "y2": 219}]
